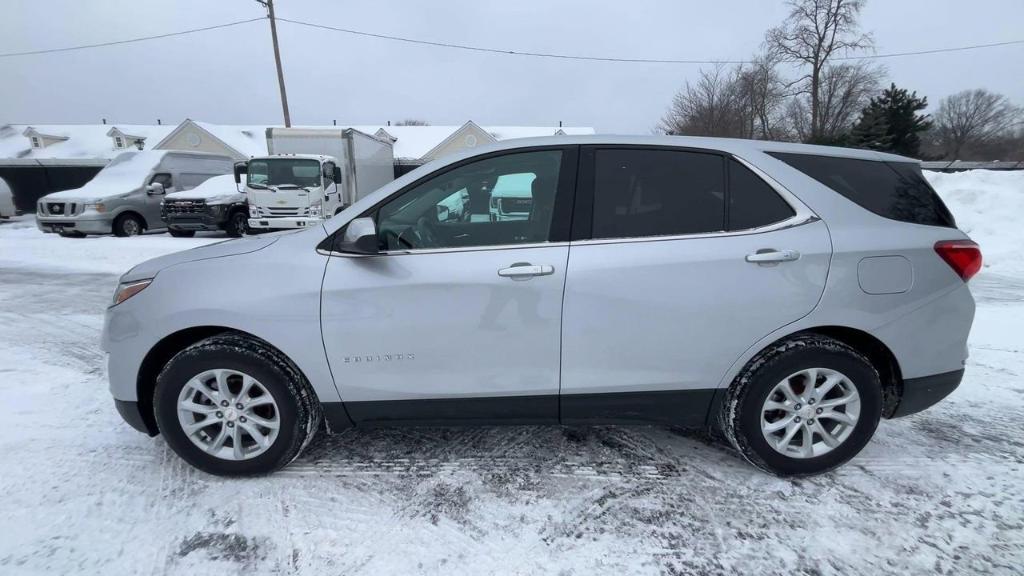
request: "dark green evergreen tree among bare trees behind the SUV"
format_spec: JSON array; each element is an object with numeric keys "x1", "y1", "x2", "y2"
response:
[{"x1": 852, "y1": 84, "x2": 932, "y2": 157}]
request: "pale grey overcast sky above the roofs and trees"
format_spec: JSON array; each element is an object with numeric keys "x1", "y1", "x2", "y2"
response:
[{"x1": 0, "y1": 0, "x2": 1024, "y2": 133}]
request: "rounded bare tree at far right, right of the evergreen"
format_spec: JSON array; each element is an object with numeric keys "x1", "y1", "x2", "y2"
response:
[{"x1": 935, "y1": 89, "x2": 1024, "y2": 160}]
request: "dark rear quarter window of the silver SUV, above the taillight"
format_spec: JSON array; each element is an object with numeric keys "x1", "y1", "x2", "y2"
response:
[{"x1": 771, "y1": 153, "x2": 956, "y2": 228}]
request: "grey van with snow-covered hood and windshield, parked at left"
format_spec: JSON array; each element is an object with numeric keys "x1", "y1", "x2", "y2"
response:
[{"x1": 36, "y1": 150, "x2": 232, "y2": 236}]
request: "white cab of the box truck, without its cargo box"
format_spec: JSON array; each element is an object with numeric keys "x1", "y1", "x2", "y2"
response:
[{"x1": 234, "y1": 154, "x2": 343, "y2": 229}]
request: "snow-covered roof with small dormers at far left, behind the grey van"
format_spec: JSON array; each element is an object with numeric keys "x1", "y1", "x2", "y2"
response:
[{"x1": 0, "y1": 124, "x2": 174, "y2": 163}]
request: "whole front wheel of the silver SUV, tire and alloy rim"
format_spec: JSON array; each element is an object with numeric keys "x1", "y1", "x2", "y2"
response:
[{"x1": 154, "y1": 334, "x2": 322, "y2": 476}]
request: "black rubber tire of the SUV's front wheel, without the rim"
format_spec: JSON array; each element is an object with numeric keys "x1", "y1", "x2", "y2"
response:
[{"x1": 154, "y1": 334, "x2": 323, "y2": 477}]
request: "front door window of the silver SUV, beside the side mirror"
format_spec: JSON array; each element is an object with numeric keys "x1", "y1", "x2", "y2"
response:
[{"x1": 378, "y1": 150, "x2": 562, "y2": 250}]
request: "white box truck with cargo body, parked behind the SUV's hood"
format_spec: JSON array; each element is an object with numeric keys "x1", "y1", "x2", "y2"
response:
[{"x1": 243, "y1": 128, "x2": 394, "y2": 230}]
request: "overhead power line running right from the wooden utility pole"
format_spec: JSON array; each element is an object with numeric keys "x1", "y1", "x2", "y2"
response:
[{"x1": 278, "y1": 17, "x2": 1024, "y2": 64}]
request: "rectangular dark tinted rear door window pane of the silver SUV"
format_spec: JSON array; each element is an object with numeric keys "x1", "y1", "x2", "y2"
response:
[{"x1": 593, "y1": 150, "x2": 725, "y2": 238}]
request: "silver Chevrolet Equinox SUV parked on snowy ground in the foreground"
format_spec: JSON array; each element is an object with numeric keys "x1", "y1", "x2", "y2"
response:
[{"x1": 103, "y1": 136, "x2": 981, "y2": 475}]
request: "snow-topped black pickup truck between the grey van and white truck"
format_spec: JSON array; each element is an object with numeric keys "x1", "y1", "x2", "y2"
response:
[{"x1": 160, "y1": 174, "x2": 249, "y2": 238}]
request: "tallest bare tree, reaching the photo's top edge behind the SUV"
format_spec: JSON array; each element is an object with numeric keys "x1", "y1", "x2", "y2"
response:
[{"x1": 765, "y1": 0, "x2": 873, "y2": 140}]
